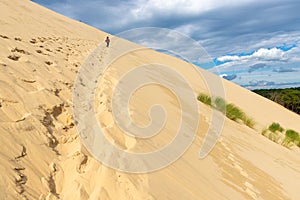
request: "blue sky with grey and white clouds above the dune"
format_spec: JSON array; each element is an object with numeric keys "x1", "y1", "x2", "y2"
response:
[{"x1": 34, "y1": 0, "x2": 300, "y2": 89}]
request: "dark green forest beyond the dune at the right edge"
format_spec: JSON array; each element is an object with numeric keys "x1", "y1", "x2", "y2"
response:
[{"x1": 252, "y1": 87, "x2": 300, "y2": 114}]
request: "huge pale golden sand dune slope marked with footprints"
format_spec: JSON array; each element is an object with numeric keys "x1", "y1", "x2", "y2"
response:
[{"x1": 0, "y1": 0, "x2": 300, "y2": 200}]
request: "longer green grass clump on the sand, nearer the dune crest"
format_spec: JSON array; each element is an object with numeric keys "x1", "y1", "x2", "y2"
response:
[{"x1": 197, "y1": 93, "x2": 255, "y2": 128}]
